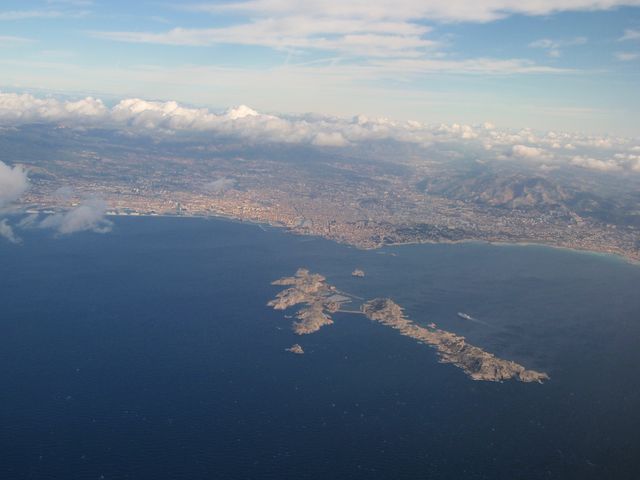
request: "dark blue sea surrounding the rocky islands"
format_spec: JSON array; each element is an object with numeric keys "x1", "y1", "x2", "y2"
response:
[{"x1": 0, "y1": 218, "x2": 640, "y2": 480}]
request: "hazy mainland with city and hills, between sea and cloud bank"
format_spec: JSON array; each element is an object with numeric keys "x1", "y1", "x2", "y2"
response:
[{"x1": 6, "y1": 126, "x2": 640, "y2": 261}]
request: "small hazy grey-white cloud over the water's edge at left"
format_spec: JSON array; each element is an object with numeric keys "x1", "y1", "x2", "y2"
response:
[{"x1": 39, "y1": 199, "x2": 113, "y2": 235}]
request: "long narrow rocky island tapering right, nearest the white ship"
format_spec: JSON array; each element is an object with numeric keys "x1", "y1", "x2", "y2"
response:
[{"x1": 362, "y1": 298, "x2": 549, "y2": 383}]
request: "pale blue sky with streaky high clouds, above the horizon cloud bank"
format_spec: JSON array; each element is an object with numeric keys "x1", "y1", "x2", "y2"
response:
[{"x1": 0, "y1": 0, "x2": 640, "y2": 136}]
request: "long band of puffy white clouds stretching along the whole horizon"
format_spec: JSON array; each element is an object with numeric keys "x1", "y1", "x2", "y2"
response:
[{"x1": 0, "y1": 93, "x2": 640, "y2": 172}]
